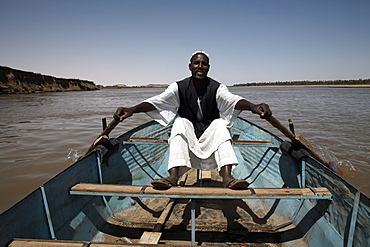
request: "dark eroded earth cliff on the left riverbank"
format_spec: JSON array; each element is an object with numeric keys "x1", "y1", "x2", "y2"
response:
[{"x1": 0, "y1": 66, "x2": 99, "y2": 94}]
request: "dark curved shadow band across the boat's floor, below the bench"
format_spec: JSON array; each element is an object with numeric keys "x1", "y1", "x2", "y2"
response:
[{"x1": 98, "y1": 200, "x2": 330, "y2": 246}]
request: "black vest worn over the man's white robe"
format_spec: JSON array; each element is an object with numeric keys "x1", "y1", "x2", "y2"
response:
[{"x1": 177, "y1": 77, "x2": 220, "y2": 138}]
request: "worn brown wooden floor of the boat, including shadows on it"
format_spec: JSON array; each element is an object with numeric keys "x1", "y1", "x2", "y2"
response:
[{"x1": 92, "y1": 169, "x2": 330, "y2": 246}]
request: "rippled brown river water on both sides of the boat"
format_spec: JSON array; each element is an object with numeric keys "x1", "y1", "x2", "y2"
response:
[{"x1": 0, "y1": 87, "x2": 370, "y2": 213}]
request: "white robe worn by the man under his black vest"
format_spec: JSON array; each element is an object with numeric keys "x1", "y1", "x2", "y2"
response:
[{"x1": 144, "y1": 83, "x2": 243, "y2": 170}]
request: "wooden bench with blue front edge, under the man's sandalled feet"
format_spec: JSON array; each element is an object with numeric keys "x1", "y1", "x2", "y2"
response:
[{"x1": 70, "y1": 183, "x2": 332, "y2": 199}]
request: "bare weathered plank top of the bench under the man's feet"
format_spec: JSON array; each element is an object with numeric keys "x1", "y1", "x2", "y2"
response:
[{"x1": 71, "y1": 183, "x2": 331, "y2": 198}]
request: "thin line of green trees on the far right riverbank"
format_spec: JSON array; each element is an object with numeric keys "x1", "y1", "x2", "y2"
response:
[{"x1": 233, "y1": 79, "x2": 370, "y2": 87}]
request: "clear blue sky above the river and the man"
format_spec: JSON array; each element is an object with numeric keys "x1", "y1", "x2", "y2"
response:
[{"x1": 0, "y1": 0, "x2": 370, "y2": 85}]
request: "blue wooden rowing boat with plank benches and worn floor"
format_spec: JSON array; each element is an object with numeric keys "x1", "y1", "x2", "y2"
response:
[{"x1": 0, "y1": 118, "x2": 370, "y2": 247}]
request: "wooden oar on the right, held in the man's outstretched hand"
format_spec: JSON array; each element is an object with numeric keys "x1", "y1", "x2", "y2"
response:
[{"x1": 266, "y1": 116, "x2": 342, "y2": 175}]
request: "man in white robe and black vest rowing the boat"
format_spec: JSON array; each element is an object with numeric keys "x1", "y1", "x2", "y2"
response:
[{"x1": 114, "y1": 51, "x2": 272, "y2": 189}]
